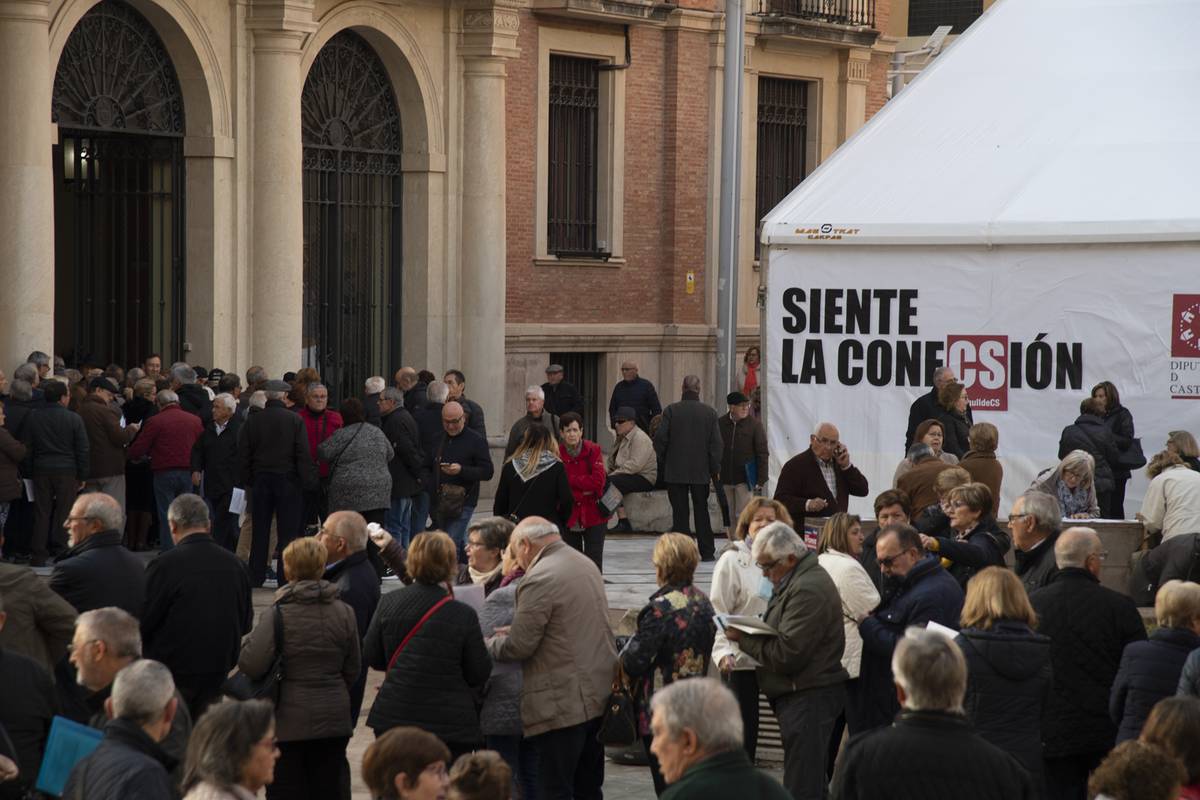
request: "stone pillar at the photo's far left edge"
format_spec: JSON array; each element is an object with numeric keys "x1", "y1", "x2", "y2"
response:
[{"x1": 0, "y1": 0, "x2": 54, "y2": 369}]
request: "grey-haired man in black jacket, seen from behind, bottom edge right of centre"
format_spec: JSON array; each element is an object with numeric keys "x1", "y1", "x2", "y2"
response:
[{"x1": 833, "y1": 627, "x2": 1036, "y2": 800}]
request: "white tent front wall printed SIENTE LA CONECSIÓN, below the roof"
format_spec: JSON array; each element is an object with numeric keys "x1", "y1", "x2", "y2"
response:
[{"x1": 763, "y1": 245, "x2": 1200, "y2": 518}]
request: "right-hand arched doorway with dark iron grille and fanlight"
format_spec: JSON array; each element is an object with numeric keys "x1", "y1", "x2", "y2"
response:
[{"x1": 301, "y1": 30, "x2": 402, "y2": 398}]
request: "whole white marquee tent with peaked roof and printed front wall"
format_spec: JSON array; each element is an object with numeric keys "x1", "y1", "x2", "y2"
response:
[{"x1": 762, "y1": 0, "x2": 1200, "y2": 517}]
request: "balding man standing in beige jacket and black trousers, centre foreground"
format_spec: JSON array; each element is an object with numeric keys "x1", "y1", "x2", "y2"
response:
[{"x1": 487, "y1": 517, "x2": 617, "y2": 800}]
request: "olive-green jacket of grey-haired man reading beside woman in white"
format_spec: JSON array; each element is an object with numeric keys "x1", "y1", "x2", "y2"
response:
[{"x1": 740, "y1": 553, "x2": 850, "y2": 699}]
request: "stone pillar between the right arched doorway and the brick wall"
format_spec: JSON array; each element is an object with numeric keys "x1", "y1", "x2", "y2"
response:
[{"x1": 460, "y1": 7, "x2": 520, "y2": 435}]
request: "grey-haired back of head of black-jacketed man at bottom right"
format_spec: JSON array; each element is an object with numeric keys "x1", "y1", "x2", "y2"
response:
[{"x1": 892, "y1": 625, "x2": 967, "y2": 712}]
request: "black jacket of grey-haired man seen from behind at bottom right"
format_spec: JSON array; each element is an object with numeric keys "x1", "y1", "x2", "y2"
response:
[{"x1": 830, "y1": 711, "x2": 1040, "y2": 800}]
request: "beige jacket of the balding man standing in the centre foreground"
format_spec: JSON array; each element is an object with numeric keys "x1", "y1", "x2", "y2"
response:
[{"x1": 487, "y1": 541, "x2": 617, "y2": 736}]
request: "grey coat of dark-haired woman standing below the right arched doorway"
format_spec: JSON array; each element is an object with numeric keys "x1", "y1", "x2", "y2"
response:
[{"x1": 317, "y1": 422, "x2": 392, "y2": 512}]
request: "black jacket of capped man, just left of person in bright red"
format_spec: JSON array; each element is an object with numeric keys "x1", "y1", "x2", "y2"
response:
[{"x1": 238, "y1": 401, "x2": 317, "y2": 488}]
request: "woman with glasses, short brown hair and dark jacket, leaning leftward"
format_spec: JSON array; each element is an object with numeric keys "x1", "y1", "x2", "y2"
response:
[{"x1": 920, "y1": 483, "x2": 1013, "y2": 587}]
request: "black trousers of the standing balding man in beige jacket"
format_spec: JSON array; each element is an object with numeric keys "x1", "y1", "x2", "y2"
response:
[{"x1": 527, "y1": 717, "x2": 604, "y2": 800}]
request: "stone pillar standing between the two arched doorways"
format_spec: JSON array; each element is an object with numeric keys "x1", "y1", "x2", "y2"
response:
[{"x1": 247, "y1": 2, "x2": 314, "y2": 378}]
